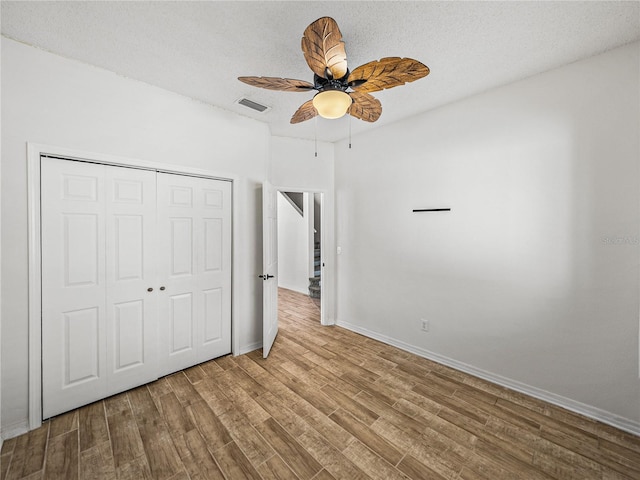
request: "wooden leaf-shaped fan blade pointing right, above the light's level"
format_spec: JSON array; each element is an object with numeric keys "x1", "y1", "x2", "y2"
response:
[{"x1": 347, "y1": 57, "x2": 429, "y2": 92}]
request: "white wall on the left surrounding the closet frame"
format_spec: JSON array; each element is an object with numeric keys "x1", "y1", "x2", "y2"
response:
[{"x1": 1, "y1": 38, "x2": 270, "y2": 433}]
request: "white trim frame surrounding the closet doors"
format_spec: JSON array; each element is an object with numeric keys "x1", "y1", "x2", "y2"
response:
[{"x1": 27, "y1": 143, "x2": 240, "y2": 430}]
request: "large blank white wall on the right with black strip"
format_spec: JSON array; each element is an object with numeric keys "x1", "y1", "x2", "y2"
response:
[{"x1": 335, "y1": 43, "x2": 640, "y2": 433}]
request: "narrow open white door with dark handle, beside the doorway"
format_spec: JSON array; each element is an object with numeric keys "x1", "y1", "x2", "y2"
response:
[{"x1": 260, "y1": 182, "x2": 278, "y2": 358}]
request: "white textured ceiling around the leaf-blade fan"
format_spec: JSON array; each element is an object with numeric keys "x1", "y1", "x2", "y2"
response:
[{"x1": 1, "y1": 0, "x2": 640, "y2": 141}]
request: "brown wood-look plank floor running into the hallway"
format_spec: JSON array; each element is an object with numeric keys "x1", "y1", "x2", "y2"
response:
[{"x1": 0, "y1": 290, "x2": 640, "y2": 480}]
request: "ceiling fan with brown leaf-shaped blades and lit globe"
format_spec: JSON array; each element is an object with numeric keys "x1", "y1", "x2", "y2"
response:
[{"x1": 238, "y1": 17, "x2": 429, "y2": 123}]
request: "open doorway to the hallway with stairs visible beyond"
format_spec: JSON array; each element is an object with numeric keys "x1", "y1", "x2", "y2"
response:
[{"x1": 277, "y1": 189, "x2": 325, "y2": 324}]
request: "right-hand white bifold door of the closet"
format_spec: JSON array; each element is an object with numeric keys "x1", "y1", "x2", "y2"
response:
[{"x1": 158, "y1": 173, "x2": 231, "y2": 375}]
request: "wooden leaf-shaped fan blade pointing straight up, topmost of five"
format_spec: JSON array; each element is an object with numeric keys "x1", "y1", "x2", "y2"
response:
[{"x1": 302, "y1": 17, "x2": 347, "y2": 79}]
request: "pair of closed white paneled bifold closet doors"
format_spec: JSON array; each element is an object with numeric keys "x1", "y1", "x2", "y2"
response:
[{"x1": 41, "y1": 158, "x2": 231, "y2": 418}]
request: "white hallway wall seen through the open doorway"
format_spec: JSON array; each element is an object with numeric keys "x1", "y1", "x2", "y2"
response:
[{"x1": 278, "y1": 192, "x2": 309, "y2": 295}]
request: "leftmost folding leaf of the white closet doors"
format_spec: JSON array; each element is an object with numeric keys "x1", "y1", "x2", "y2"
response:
[{"x1": 41, "y1": 159, "x2": 107, "y2": 418}]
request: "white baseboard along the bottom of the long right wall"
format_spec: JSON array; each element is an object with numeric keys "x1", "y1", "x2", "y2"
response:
[{"x1": 336, "y1": 320, "x2": 640, "y2": 436}]
